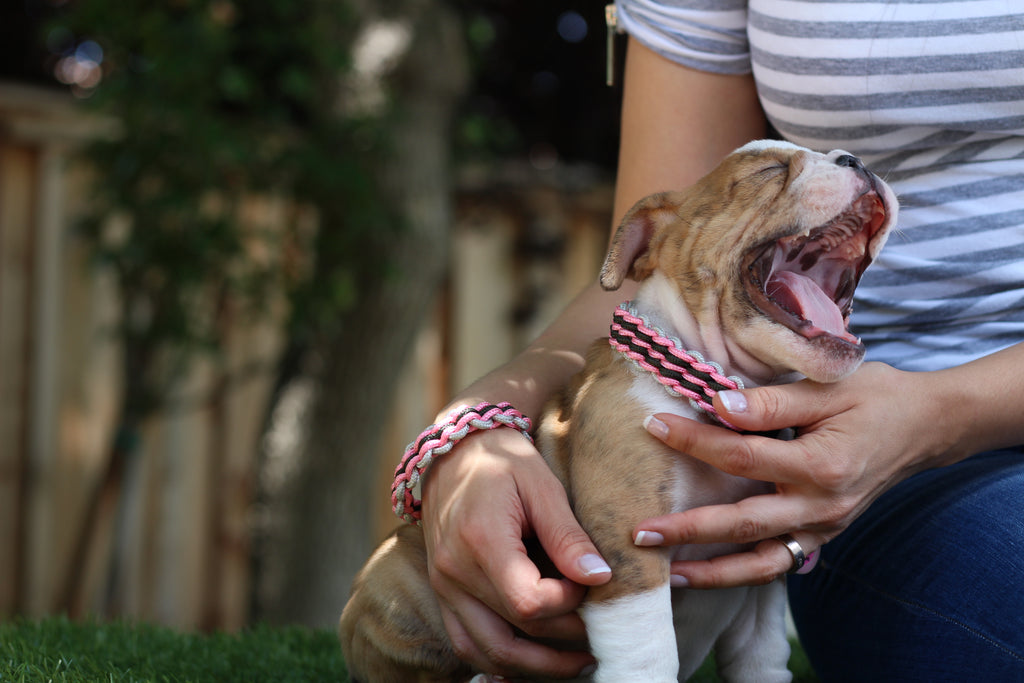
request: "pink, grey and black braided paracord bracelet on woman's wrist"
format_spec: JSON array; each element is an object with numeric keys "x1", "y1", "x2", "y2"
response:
[{"x1": 391, "y1": 402, "x2": 534, "y2": 524}]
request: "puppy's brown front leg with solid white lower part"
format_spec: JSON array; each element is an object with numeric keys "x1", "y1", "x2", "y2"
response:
[{"x1": 548, "y1": 382, "x2": 680, "y2": 683}]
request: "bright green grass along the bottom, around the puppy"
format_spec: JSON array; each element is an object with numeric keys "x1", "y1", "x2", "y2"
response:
[{"x1": 0, "y1": 617, "x2": 818, "y2": 683}]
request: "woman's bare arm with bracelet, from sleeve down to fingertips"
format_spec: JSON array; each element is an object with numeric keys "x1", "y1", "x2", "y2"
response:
[{"x1": 423, "y1": 41, "x2": 765, "y2": 676}]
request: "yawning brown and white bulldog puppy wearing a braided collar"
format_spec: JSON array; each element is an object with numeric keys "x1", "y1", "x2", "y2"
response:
[{"x1": 341, "y1": 141, "x2": 897, "y2": 683}]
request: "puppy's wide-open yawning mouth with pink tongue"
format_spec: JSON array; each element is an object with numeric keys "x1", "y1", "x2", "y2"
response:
[{"x1": 744, "y1": 188, "x2": 886, "y2": 346}]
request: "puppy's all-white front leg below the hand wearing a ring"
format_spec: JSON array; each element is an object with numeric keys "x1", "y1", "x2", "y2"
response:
[{"x1": 716, "y1": 579, "x2": 793, "y2": 683}]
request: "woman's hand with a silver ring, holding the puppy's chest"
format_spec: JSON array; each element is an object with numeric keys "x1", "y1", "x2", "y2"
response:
[{"x1": 634, "y1": 364, "x2": 965, "y2": 588}]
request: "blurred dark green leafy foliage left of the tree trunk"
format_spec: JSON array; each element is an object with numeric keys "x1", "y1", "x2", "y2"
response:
[{"x1": 48, "y1": 0, "x2": 394, "y2": 411}]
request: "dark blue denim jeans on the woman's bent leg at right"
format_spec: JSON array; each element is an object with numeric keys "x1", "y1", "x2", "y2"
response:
[{"x1": 788, "y1": 447, "x2": 1024, "y2": 683}]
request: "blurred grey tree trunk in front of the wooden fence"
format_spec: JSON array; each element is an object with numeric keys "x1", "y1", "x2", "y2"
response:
[{"x1": 258, "y1": 0, "x2": 467, "y2": 627}]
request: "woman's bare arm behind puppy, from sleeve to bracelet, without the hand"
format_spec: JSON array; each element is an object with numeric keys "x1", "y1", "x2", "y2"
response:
[{"x1": 442, "y1": 41, "x2": 765, "y2": 423}]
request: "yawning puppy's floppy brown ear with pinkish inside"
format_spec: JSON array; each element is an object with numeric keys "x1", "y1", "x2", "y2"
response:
[{"x1": 600, "y1": 193, "x2": 681, "y2": 291}]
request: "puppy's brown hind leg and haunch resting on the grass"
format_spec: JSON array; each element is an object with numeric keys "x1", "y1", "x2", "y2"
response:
[{"x1": 339, "y1": 525, "x2": 472, "y2": 683}]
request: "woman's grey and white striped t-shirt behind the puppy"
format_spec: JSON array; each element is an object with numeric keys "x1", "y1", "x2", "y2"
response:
[{"x1": 617, "y1": 0, "x2": 1024, "y2": 370}]
